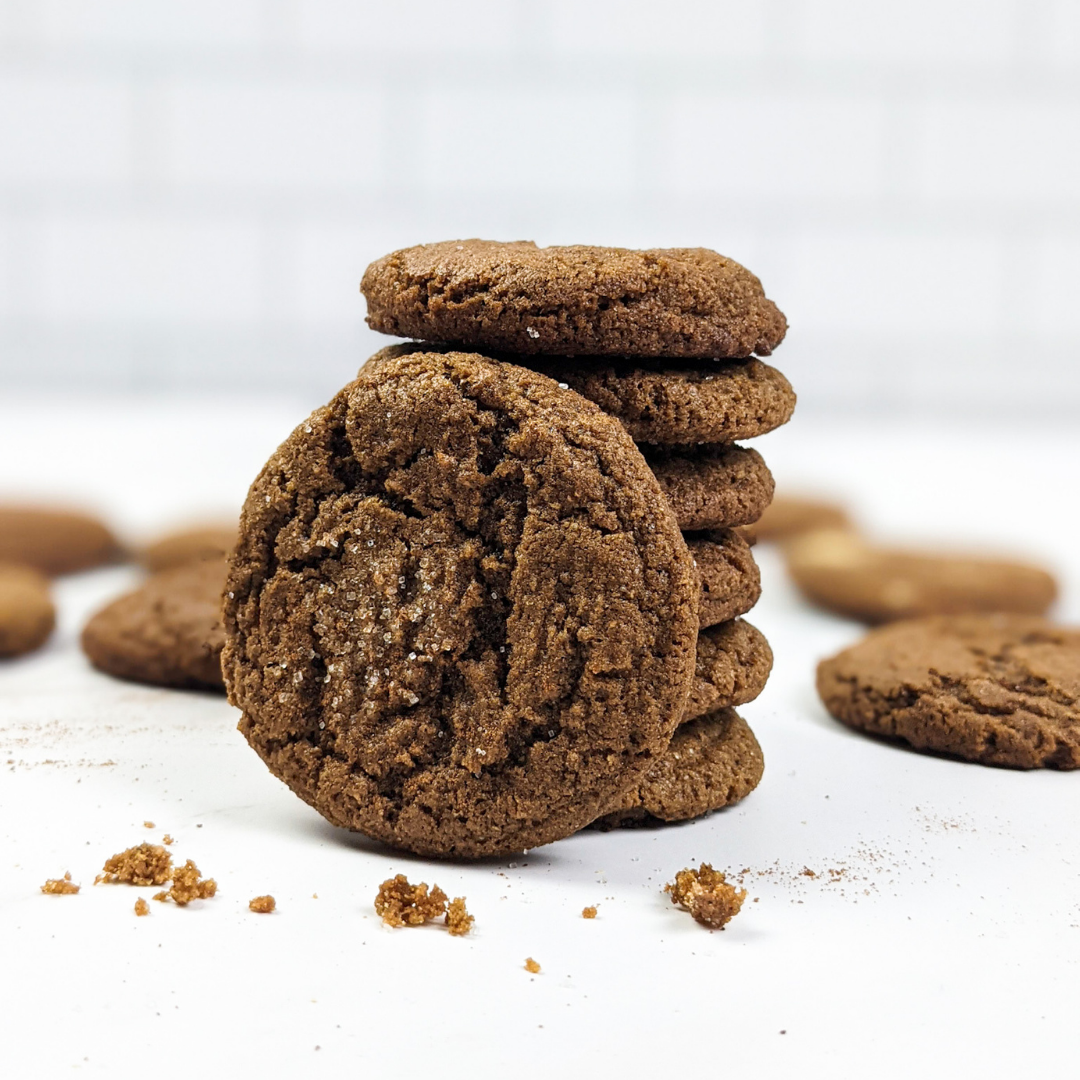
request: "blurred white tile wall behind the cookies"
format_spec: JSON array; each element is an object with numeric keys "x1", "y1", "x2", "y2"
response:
[{"x1": 0, "y1": 0, "x2": 1080, "y2": 416}]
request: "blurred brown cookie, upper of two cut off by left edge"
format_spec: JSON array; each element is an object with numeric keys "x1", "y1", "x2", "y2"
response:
[{"x1": 0, "y1": 505, "x2": 122, "y2": 576}]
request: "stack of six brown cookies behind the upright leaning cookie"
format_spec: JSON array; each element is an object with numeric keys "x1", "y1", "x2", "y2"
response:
[{"x1": 361, "y1": 241, "x2": 795, "y2": 825}]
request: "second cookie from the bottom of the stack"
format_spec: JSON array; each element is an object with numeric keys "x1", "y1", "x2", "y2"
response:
[{"x1": 683, "y1": 619, "x2": 772, "y2": 724}]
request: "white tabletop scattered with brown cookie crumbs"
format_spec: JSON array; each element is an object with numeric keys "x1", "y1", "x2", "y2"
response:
[{"x1": 0, "y1": 401, "x2": 1080, "y2": 1080}]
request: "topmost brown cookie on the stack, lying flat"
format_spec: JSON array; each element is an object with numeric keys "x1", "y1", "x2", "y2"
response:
[{"x1": 360, "y1": 240, "x2": 787, "y2": 357}]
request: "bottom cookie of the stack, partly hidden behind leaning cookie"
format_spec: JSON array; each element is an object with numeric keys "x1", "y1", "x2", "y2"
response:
[{"x1": 594, "y1": 708, "x2": 765, "y2": 829}]
